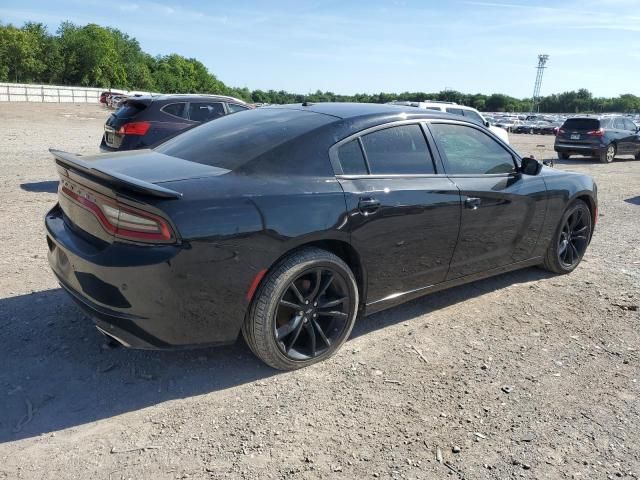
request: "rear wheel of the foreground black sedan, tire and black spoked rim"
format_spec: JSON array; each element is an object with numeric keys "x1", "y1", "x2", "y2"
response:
[{"x1": 242, "y1": 248, "x2": 359, "y2": 370}]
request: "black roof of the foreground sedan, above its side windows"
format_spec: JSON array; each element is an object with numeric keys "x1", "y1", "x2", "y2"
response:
[{"x1": 268, "y1": 102, "x2": 464, "y2": 120}]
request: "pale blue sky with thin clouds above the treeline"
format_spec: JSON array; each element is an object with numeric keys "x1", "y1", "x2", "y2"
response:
[{"x1": 0, "y1": 0, "x2": 640, "y2": 98}]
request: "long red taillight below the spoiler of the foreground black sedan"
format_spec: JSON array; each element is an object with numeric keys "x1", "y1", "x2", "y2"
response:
[{"x1": 62, "y1": 186, "x2": 174, "y2": 243}]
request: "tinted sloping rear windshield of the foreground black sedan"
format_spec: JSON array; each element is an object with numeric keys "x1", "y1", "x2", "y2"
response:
[{"x1": 155, "y1": 108, "x2": 335, "y2": 170}]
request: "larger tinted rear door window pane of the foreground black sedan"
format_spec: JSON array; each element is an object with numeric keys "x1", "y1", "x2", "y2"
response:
[{"x1": 362, "y1": 124, "x2": 435, "y2": 175}]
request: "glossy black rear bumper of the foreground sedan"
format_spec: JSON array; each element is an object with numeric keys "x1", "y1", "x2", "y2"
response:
[{"x1": 45, "y1": 206, "x2": 244, "y2": 349}]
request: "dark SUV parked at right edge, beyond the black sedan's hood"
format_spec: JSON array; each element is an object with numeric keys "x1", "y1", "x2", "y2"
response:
[{"x1": 553, "y1": 116, "x2": 640, "y2": 163}]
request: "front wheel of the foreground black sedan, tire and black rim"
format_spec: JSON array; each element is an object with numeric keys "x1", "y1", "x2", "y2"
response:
[{"x1": 542, "y1": 200, "x2": 593, "y2": 274}]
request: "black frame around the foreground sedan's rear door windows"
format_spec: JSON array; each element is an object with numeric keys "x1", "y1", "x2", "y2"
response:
[{"x1": 329, "y1": 118, "x2": 444, "y2": 180}]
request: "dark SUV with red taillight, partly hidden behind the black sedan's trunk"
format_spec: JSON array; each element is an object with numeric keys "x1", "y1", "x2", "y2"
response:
[{"x1": 100, "y1": 95, "x2": 253, "y2": 152}]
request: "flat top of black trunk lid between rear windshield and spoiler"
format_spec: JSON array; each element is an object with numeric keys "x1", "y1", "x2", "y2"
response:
[{"x1": 79, "y1": 150, "x2": 229, "y2": 183}]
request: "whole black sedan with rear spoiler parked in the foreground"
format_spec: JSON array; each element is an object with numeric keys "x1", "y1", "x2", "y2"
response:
[{"x1": 45, "y1": 103, "x2": 597, "y2": 369}]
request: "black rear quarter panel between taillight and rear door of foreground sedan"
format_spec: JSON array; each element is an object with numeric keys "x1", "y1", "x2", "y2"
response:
[{"x1": 151, "y1": 174, "x2": 349, "y2": 340}]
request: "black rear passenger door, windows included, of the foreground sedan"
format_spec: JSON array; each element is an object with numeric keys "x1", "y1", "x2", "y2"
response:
[{"x1": 331, "y1": 122, "x2": 461, "y2": 304}]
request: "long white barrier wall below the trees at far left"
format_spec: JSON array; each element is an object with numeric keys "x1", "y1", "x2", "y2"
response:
[{"x1": 0, "y1": 83, "x2": 127, "y2": 103}]
